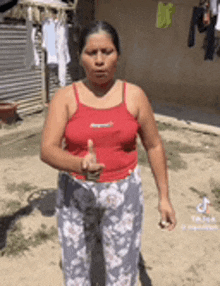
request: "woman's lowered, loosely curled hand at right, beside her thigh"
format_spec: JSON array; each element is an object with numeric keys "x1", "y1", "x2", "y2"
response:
[{"x1": 158, "y1": 199, "x2": 177, "y2": 231}]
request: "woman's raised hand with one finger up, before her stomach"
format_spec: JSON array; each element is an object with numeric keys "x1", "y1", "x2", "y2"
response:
[{"x1": 82, "y1": 139, "x2": 105, "y2": 182}]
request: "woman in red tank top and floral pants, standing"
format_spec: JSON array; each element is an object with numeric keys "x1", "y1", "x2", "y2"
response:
[{"x1": 41, "y1": 21, "x2": 176, "y2": 286}]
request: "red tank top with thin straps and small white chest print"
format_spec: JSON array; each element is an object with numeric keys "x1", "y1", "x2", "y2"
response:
[{"x1": 65, "y1": 83, "x2": 140, "y2": 182}]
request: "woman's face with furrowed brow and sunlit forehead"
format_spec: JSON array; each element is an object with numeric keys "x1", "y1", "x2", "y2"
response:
[{"x1": 81, "y1": 31, "x2": 119, "y2": 84}]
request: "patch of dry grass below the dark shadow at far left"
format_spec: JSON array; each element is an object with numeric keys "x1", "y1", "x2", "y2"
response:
[{"x1": 0, "y1": 222, "x2": 58, "y2": 257}]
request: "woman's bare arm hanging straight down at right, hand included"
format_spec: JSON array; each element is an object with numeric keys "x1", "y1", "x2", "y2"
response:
[{"x1": 137, "y1": 86, "x2": 176, "y2": 230}]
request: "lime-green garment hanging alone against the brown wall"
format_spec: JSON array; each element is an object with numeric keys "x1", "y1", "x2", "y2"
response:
[{"x1": 156, "y1": 2, "x2": 176, "y2": 28}]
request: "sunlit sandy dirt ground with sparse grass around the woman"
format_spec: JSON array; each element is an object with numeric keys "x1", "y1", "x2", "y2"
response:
[{"x1": 0, "y1": 111, "x2": 220, "y2": 286}]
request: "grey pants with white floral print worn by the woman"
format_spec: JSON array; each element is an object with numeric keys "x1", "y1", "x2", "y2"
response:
[{"x1": 57, "y1": 168, "x2": 143, "y2": 286}]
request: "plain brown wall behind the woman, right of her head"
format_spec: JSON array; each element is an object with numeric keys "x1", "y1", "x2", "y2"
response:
[{"x1": 96, "y1": 0, "x2": 220, "y2": 112}]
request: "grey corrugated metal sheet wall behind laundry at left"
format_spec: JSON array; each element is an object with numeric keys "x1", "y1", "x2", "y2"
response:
[{"x1": 0, "y1": 24, "x2": 44, "y2": 115}]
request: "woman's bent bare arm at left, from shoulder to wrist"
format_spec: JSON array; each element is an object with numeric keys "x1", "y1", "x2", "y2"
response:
[{"x1": 41, "y1": 90, "x2": 82, "y2": 173}]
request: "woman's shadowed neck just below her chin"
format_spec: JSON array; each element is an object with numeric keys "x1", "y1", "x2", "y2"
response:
[{"x1": 83, "y1": 79, "x2": 115, "y2": 98}]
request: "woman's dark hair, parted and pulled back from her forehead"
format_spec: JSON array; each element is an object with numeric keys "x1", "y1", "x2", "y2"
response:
[{"x1": 78, "y1": 21, "x2": 121, "y2": 55}]
